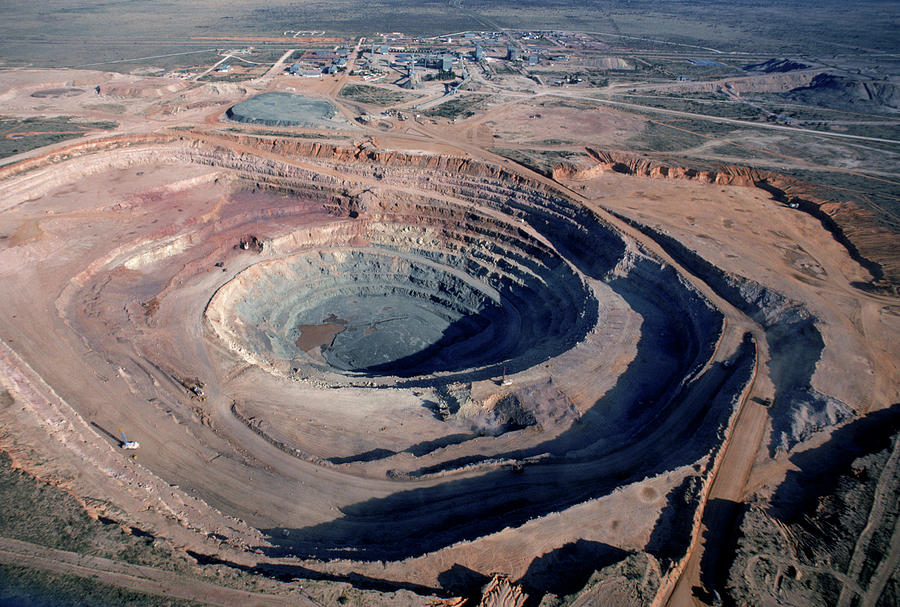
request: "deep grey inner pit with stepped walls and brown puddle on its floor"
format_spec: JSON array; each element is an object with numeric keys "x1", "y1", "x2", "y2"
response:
[{"x1": 210, "y1": 234, "x2": 597, "y2": 377}]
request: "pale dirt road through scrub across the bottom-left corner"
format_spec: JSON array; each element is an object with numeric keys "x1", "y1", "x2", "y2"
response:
[{"x1": 0, "y1": 538, "x2": 321, "y2": 607}]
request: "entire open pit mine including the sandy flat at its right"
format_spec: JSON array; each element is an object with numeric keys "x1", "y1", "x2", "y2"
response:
[{"x1": 0, "y1": 131, "x2": 896, "y2": 605}]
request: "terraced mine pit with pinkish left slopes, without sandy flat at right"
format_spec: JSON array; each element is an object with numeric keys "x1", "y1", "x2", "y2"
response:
[{"x1": 0, "y1": 129, "x2": 888, "y2": 604}]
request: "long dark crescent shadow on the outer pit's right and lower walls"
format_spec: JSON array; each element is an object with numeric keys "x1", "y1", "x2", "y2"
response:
[{"x1": 229, "y1": 201, "x2": 756, "y2": 591}]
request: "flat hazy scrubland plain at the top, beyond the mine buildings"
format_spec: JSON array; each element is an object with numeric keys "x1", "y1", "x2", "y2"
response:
[{"x1": 4, "y1": 0, "x2": 896, "y2": 72}]
